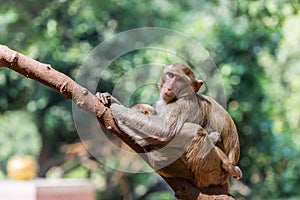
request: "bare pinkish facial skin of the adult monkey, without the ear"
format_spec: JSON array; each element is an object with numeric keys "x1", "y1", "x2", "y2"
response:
[{"x1": 160, "y1": 72, "x2": 187, "y2": 103}]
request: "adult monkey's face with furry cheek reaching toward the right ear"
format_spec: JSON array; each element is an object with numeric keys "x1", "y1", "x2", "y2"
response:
[{"x1": 160, "y1": 72, "x2": 193, "y2": 103}]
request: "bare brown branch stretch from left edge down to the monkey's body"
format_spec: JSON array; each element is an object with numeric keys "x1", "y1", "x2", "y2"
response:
[{"x1": 0, "y1": 45, "x2": 143, "y2": 153}]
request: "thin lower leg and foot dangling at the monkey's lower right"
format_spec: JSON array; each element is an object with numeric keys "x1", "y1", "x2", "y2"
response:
[{"x1": 215, "y1": 146, "x2": 243, "y2": 179}]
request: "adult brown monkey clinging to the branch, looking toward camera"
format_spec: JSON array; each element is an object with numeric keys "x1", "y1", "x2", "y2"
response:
[{"x1": 97, "y1": 63, "x2": 242, "y2": 190}]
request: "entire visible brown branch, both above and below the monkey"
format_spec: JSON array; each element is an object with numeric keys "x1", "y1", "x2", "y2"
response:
[{"x1": 0, "y1": 45, "x2": 234, "y2": 200}]
